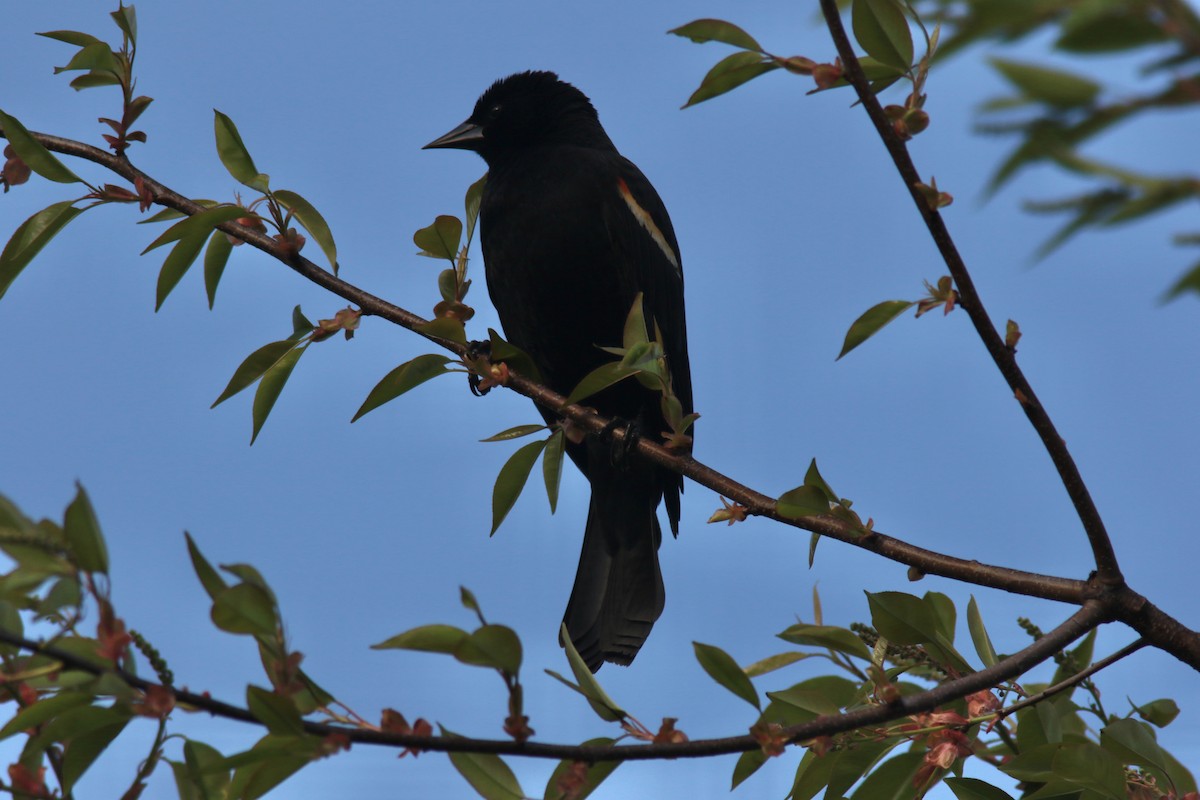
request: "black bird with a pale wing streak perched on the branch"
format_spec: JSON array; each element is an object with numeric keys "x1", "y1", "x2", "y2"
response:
[{"x1": 426, "y1": 72, "x2": 692, "y2": 672}]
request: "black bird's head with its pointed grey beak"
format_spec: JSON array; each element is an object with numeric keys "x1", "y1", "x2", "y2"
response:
[{"x1": 422, "y1": 72, "x2": 613, "y2": 166}]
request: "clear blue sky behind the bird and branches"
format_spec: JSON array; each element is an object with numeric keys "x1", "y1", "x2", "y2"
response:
[{"x1": 0, "y1": 0, "x2": 1200, "y2": 798}]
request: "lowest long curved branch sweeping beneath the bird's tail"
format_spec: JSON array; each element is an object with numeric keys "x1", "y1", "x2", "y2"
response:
[{"x1": 0, "y1": 601, "x2": 1108, "y2": 763}]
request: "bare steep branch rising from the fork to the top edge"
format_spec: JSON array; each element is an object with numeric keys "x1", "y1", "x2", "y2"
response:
[{"x1": 821, "y1": 0, "x2": 1124, "y2": 587}]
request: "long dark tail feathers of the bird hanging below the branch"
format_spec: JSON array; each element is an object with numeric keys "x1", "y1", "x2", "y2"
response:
[{"x1": 563, "y1": 481, "x2": 666, "y2": 672}]
